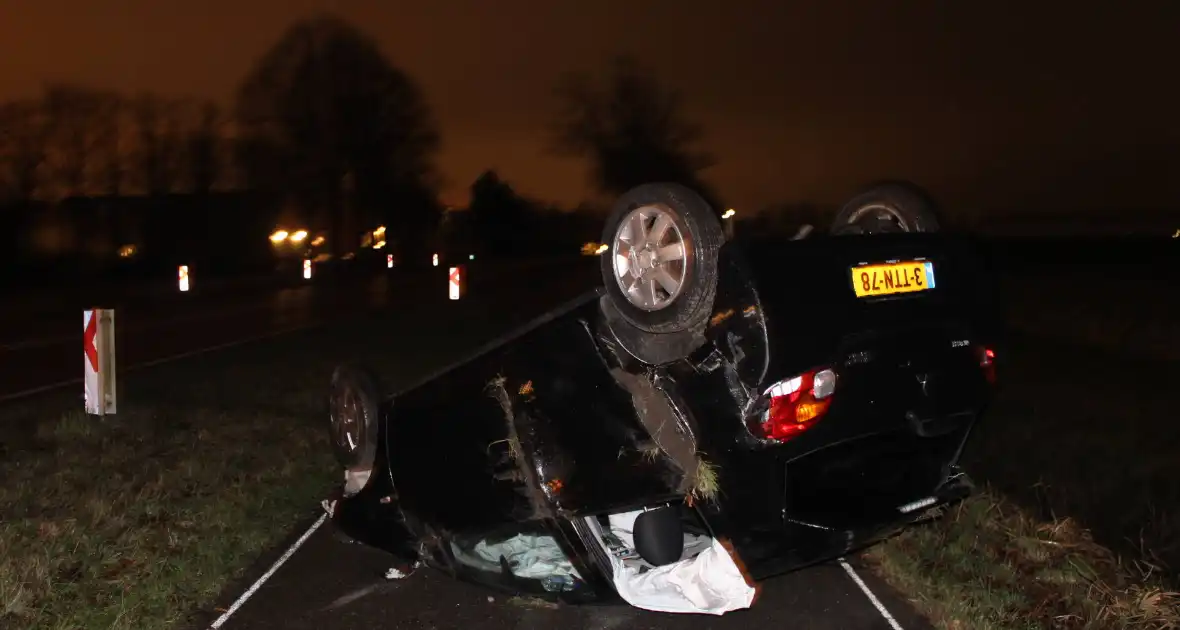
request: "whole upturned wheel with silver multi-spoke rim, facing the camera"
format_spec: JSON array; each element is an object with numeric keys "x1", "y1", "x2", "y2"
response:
[{"x1": 602, "y1": 183, "x2": 725, "y2": 333}]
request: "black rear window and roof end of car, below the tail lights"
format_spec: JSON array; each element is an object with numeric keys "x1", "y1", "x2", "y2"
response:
[{"x1": 703, "y1": 414, "x2": 976, "y2": 579}]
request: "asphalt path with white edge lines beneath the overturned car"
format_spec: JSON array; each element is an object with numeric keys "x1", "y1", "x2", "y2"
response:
[{"x1": 198, "y1": 524, "x2": 932, "y2": 630}]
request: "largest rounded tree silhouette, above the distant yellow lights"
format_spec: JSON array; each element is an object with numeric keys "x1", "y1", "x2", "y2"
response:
[{"x1": 236, "y1": 15, "x2": 439, "y2": 259}]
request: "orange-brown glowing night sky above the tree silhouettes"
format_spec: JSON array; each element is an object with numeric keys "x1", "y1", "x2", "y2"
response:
[{"x1": 0, "y1": 0, "x2": 1180, "y2": 211}]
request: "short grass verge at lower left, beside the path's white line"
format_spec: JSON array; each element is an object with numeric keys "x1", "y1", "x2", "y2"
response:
[{"x1": 0, "y1": 406, "x2": 333, "y2": 630}]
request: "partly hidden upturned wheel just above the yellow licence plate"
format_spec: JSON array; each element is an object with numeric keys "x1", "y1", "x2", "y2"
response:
[{"x1": 831, "y1": 182, "x2": 939, "y2": 235}]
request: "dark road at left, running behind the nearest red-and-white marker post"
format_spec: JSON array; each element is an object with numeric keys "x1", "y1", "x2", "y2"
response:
[{"x1": 0, "y1": 261, "x2": 586, "y2": 402}]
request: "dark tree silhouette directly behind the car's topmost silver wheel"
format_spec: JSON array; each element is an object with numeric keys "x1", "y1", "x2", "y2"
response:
[{"x1": 553, "y1": 57, "x2": 716, "y2": 209}]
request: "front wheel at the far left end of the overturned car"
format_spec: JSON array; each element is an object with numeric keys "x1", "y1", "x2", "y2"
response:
[{"x1": 328, "y1": 363, "x2": 381, "y2": 472}]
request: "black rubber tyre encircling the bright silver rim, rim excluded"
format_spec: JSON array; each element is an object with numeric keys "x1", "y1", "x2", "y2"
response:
[{"x1": 601, "y1": 183, "x2": 725, "y2": 333}]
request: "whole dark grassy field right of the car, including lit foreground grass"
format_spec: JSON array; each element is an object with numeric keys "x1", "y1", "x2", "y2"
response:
[{"x1": 867, "y1": 264, "x2": 1180, "y2": 630}]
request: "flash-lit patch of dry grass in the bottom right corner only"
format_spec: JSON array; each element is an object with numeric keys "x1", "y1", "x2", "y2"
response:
[{"x1": 866, "y1": 491, "x2": 1180, "y2": 630}]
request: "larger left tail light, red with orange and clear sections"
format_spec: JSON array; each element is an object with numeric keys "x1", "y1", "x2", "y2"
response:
[{"x1": 759, "y1": 368, "x2": 835, "y2": 441}]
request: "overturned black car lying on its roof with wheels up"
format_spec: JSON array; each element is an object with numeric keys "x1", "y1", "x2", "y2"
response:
[{"x1": 328, "y1": 184, "x2": 998, "y2": 613}]
